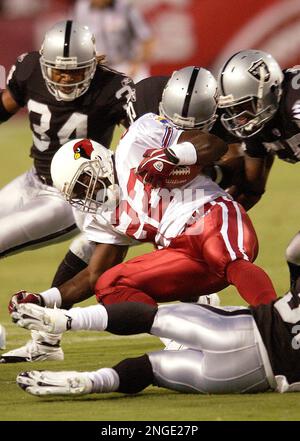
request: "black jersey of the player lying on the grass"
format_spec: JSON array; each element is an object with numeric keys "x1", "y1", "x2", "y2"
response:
[{"x1": 251, "y1": 294, "x2": 300, "y2": 384}]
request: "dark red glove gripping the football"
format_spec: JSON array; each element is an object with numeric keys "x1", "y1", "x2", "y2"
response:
[{"x1": 136, "y1": 149, "x2": 178, "y2": 187}]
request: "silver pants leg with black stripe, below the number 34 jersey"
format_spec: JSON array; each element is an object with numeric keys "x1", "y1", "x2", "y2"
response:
[{"x1": 0, "y1": 170, "x2": 77, "y2": 257}]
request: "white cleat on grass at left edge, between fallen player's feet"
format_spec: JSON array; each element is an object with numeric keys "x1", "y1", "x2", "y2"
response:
[{"x1": 0, "y1": 340, "x2": 64, "y2": 363}]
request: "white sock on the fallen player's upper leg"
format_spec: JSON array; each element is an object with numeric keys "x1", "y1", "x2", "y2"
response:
[{"x1": 66, "y1": 305, "x2": 108, "y2": 331}]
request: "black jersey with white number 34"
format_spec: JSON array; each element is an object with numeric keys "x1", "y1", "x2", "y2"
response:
[{"x1": 8, "y1": 52, "x2": 133, "y2": 183}]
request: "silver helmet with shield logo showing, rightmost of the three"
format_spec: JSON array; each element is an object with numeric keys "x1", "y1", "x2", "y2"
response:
[{"x1": 218, "y1": 49, "x2": 283, "y2": 138}]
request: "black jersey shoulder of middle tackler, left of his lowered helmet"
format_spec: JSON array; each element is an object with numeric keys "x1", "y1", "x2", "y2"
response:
[{"x1": 127, "y1": 77, "x2": 169, "y2": 122}]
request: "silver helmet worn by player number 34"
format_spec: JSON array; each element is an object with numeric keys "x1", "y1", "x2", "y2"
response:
[{"x1": 40, "y1": 20, "x2": 97, "y2": 101}]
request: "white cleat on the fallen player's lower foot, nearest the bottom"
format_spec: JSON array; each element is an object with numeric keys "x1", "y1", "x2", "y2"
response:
[{"x1": 16, "y1": 371, "x2": 93, "y2": 396}]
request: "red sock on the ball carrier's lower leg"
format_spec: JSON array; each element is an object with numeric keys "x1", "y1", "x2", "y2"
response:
[{"x1": 226, "y1": 260, "x2": 277, "y2": 306}]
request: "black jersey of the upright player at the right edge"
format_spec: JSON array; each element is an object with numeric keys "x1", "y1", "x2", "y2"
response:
[{"x1": 243, "y1": 69, "x2": 300, "y2": 163}]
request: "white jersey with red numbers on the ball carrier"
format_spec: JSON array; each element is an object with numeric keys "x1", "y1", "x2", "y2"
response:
[{"x1": 85, "y1": 113, "x2": 228, "y2": 248}]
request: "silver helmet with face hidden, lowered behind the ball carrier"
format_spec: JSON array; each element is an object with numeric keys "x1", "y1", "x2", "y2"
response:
[{"x1": 159, "y1": 66, "x2": 218, "y2": 130}]
